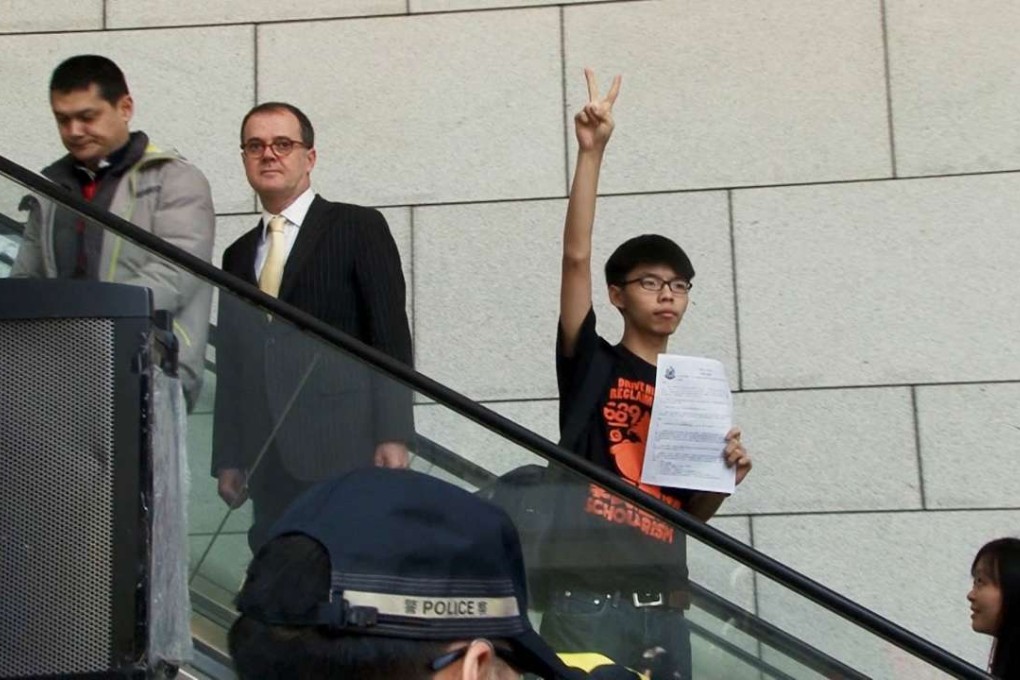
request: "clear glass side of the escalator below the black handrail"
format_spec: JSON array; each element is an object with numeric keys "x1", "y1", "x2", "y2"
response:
[{"x1": 0, "y1": 165, "x2": 975, "y2": 680}]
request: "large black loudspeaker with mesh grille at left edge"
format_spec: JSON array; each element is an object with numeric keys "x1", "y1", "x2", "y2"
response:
[{"x1": 0, "y1": 279, "x2": 167, "y2": 678}]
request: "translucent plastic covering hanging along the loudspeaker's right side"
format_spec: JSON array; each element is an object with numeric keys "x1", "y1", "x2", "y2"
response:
[{"x1": 149, "y1": 367, "x2": 192, "y2": 666}]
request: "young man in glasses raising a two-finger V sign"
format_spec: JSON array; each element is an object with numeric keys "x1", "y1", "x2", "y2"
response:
[{"x1": 542, "y1": 69, "x2": 751, "y2": 678}]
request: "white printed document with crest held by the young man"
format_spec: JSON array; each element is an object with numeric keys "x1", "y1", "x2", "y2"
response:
[{"x1": 641, "y1": 354, "x2": 736, "y2": 493}]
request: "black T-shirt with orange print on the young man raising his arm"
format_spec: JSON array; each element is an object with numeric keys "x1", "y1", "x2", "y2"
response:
[{"x1": 551, "y1": 310, "x2": 691, "y2": 591}]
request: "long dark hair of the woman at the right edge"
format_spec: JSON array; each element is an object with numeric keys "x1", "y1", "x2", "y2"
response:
[{"x1": 971, "y1": 538, "x2": 1020, "y2": 680}]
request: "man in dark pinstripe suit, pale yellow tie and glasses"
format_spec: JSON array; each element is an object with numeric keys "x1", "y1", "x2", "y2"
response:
[{"x1": 212, "y1": 102, "x2": 414, "y2": 551}]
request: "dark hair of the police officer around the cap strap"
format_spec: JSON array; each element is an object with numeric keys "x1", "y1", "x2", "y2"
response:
[{"x1": 234, "y1": 534, "x2": 448, "y2": 680}]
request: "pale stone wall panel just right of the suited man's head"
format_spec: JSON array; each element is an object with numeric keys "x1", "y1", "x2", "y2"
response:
[{"x1": 252, "y1": 8, "x2": 563, "y2": 205}]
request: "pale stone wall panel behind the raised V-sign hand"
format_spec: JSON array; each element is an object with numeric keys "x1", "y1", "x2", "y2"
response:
[{"x1": 564, "y1": 0, "x2": 890, "y2": 192}]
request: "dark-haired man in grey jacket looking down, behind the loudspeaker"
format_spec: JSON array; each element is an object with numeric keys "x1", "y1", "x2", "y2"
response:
[{"x1": 11, "y1": 55, "x2": 215, "y2": 410}]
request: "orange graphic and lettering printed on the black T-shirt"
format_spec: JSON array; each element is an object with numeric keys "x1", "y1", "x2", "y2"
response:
[{"x1": 585, "y1": 377, "x2": 680, "y2": 543}]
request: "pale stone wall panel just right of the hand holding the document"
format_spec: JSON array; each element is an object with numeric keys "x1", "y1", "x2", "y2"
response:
[{"x1": 720, "y1": 387, "x2": 921, "y2": 514}]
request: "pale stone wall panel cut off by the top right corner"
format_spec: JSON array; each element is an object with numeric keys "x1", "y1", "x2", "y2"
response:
[{"x1": 885, "y1": 0, "x2": 1020, "y2": 175}]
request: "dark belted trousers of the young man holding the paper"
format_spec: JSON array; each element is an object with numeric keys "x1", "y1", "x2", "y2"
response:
[{"x1": 541, "y1": 587, "x2": 691, "y2": 680}]
